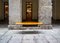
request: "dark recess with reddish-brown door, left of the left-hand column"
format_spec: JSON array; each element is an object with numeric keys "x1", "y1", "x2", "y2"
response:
[{"x1": 0, "y1": 0, "x2": 9, "y2": 28}]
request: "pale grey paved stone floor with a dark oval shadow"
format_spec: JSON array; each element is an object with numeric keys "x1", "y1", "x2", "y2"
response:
[{"x1": 0, "y1": 25, "x2": 60, "y2": 43}]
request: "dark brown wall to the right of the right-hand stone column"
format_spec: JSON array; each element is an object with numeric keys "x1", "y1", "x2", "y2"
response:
[{"x1": 53, "y1": 0, "x2": 60, "y2": 19}]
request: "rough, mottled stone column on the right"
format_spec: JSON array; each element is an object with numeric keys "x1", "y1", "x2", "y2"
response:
[{"x1": 38, "y1": 0, "x2": 52, "y2": 29}]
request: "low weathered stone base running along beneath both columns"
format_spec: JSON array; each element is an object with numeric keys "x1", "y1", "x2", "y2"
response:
[{"x1": 8, "y1": 25, "x2": 52, "y2": 30}]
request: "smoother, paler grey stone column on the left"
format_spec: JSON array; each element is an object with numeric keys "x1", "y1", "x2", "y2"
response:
[{"x1": 8, "y1": 0, "x2": 22, "y2": 27}]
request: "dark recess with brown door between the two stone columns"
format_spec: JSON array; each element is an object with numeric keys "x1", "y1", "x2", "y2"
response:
[{"x1": 22, "y1": 0, "x2": 38, "y2": 26}]
